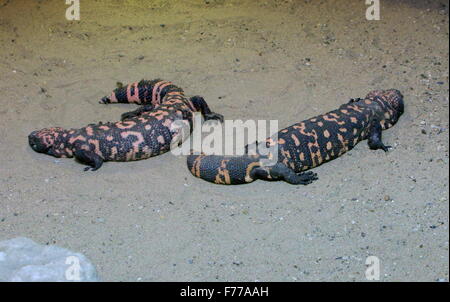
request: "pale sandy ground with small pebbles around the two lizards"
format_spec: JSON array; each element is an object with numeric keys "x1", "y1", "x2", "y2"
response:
[{"x1": 0, "y1": 0, "x2": 449, "y2": 281}]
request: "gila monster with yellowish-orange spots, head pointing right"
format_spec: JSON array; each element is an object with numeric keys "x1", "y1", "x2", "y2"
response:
[{"x1": 187, "y1": 89, "x2": 404, "y2": 185}]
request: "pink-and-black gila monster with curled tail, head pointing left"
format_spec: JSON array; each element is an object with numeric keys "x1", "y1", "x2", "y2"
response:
[{"x1": 28, "y1": 80, "x2": 223, "y2": 171}]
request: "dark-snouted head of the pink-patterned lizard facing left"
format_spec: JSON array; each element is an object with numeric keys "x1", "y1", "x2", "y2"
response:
[{"x1": 28, "y1": 127, "x2": 71, "y2": 157}]
